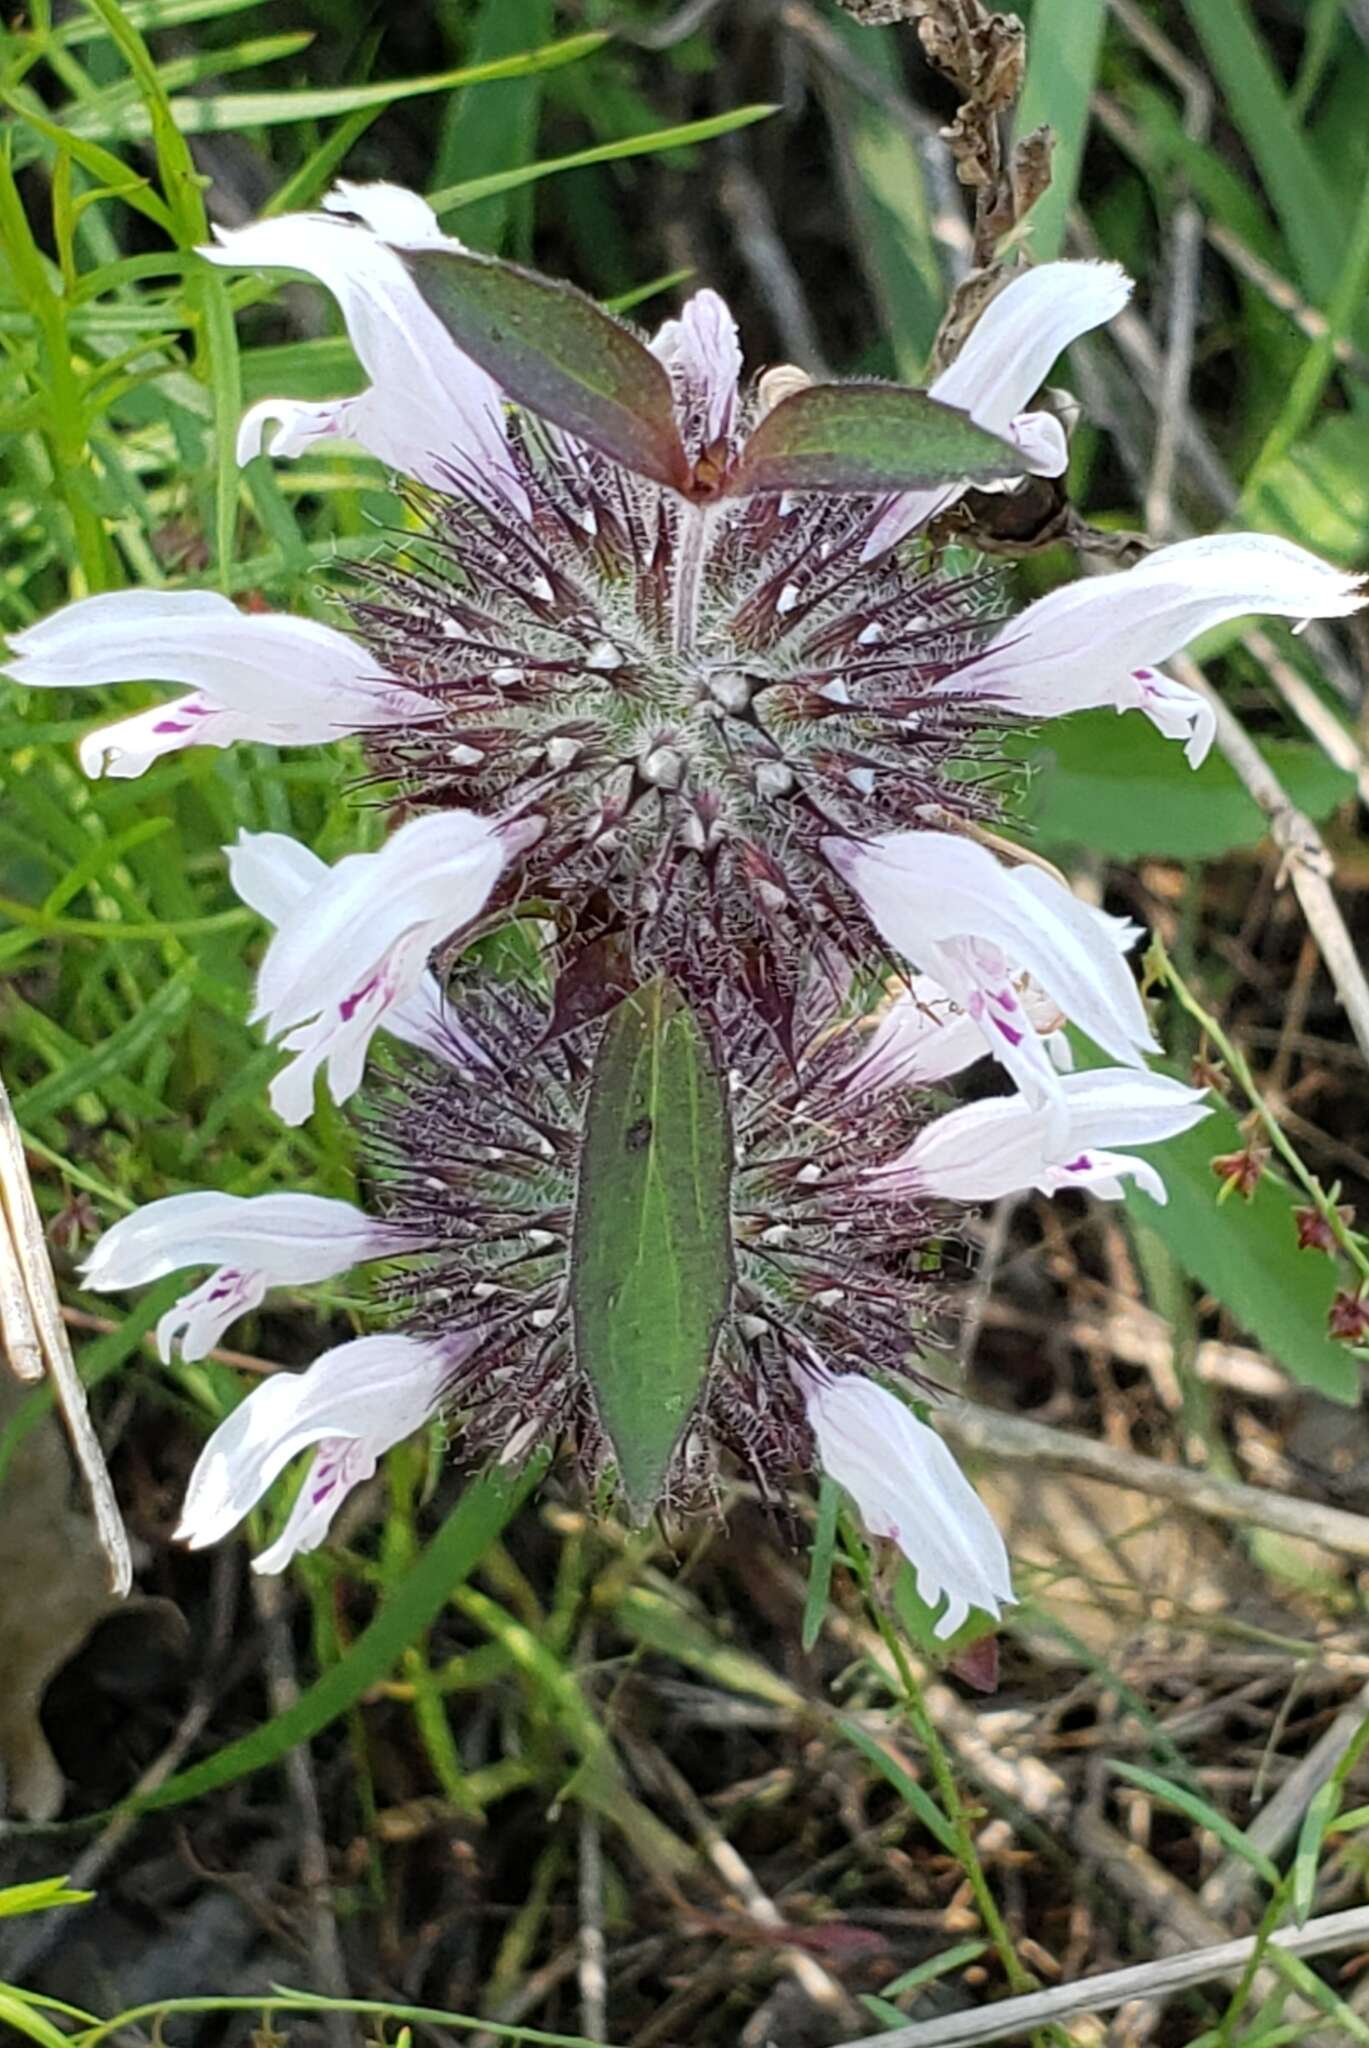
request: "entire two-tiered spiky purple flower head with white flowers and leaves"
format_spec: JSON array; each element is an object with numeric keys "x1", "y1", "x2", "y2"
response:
[{"x1": 10, "y1": 184, "x2": 1359, "y2": 1634}]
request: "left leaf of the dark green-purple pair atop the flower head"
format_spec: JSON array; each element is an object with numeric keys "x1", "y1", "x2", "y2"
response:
[{"x1": 402, "y1": 250, "x2": 691, "y2": 492}]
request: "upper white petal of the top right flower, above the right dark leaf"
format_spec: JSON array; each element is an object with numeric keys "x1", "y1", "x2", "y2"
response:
[{"x1": 928, "y1": 262, "x2": 1131, "y2": 432}]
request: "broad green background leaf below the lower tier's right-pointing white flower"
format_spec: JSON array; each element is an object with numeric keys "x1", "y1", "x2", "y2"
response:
[{"x1": 1127, "y1": 1108, "x2": 1359, "y2": 1403}]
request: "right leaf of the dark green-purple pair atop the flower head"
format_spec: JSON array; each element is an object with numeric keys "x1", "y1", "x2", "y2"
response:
[{"x1": 723, "y1": 383, "x2": 1023, "y2": 498}]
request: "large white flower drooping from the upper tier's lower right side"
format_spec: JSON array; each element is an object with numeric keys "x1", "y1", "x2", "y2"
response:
[{"x1": 822, "y1": 831, "x2": 1160, "y2": 1133}]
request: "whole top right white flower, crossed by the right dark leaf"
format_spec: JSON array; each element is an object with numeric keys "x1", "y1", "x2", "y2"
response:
[{"x1": 863, "y1": 262, "x2": 1131, "y2": 561}]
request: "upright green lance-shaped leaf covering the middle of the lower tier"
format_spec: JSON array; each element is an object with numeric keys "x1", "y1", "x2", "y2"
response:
[{"x1": 570, "y1": 979, "x2": 732, "y2": 1516}]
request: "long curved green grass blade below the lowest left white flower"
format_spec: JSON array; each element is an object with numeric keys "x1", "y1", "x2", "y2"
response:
[{"x1": 117, "y1": 1458, "x2": 545, "y2": 1815}]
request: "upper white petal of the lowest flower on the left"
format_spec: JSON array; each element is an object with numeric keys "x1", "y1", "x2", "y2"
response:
[{"x1": 176, "y1": 1335, "x2": 457, "y2": 1550}]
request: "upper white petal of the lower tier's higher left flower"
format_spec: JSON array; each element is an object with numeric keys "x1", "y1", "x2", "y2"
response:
[{"x1": 82, "y1": 1190, "x2": 391, "y2": 1294}]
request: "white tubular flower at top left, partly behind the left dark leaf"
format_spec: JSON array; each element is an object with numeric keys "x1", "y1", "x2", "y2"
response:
[{"x1": 199, "y1": 182, "x2": 527, "y2": 512}]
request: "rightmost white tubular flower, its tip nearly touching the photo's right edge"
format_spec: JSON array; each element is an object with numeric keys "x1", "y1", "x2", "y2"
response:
[{"x1": 937, "y1": 532, "x2": 1365, "y2": 768}]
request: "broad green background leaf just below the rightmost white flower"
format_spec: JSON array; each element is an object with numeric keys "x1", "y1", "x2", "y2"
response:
[{"x1": 1020, "y1": 711, "x2": 1355, "y2": 860}]
